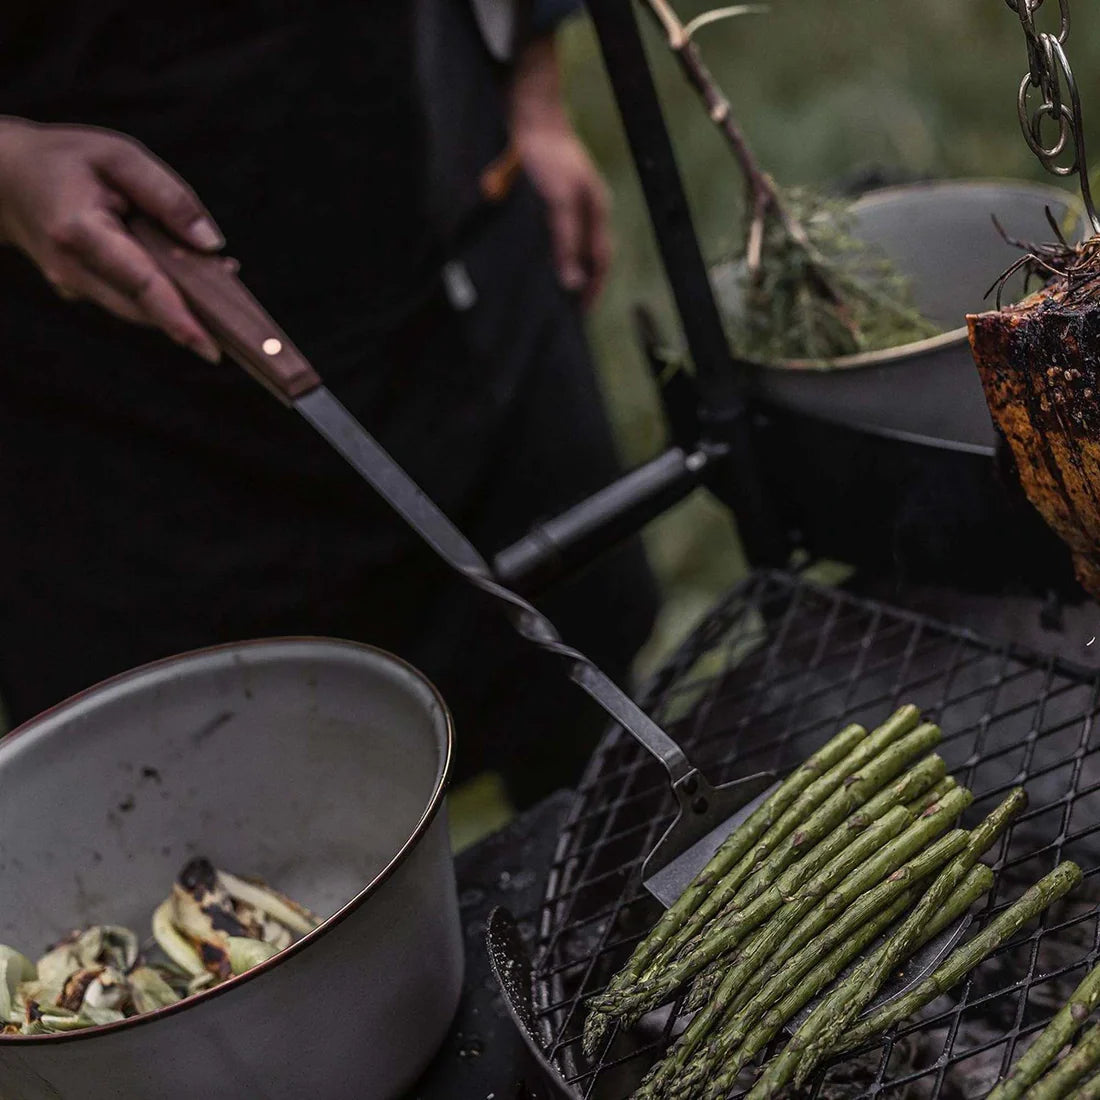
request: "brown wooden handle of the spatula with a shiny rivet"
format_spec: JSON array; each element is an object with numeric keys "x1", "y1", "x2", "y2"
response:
[{"x1": 130, "y1": 216, "x2": 321, "y2": 405}]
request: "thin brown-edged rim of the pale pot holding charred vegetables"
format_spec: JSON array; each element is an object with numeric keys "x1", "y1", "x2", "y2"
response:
[{"x1": 0, "y1": 635, "x2": 454, "y2": 1047}]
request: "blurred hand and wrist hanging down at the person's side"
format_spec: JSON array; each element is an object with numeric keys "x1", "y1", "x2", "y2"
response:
[{"x1": 512, "y1": 39, "x2": 612, "y2": 306}]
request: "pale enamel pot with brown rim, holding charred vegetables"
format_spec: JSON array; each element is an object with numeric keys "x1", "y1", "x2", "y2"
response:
[{"x1": 0, "y1": 639, "x2": 463, "y2": 1100}]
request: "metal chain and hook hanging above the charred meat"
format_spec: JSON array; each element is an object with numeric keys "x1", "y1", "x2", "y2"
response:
[{"x1": 1004, "y1": 0, "x2": 1100, "y2": 233}]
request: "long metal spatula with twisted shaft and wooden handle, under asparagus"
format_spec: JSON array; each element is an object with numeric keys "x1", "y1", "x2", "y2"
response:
[{"x1": 131, "y1": 219, "x2": 774, "y2": 905}]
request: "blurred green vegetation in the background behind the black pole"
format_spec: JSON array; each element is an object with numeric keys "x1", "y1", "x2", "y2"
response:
[{"x1": 561, "y1": 0, "x2": 1100, "y2": 671}]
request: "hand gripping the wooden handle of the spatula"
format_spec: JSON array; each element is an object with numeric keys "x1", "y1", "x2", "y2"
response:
[{"x1": 0, "y1": 119, "x2": 224, "y2": 362}]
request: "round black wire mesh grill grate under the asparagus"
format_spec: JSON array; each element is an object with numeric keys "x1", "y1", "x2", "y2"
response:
[{"x1": 535, "y1": 573, "x2": 1100, "y2": 1100}]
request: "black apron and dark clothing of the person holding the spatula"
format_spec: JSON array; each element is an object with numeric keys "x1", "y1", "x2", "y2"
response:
[{"x1": 0, "y1": 0, "x2": 653, "y2": 800}]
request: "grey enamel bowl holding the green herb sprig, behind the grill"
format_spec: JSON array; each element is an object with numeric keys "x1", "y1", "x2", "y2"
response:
[{"x1": 712, "y1": 179, "x2": 1082, "y2": 457}]
